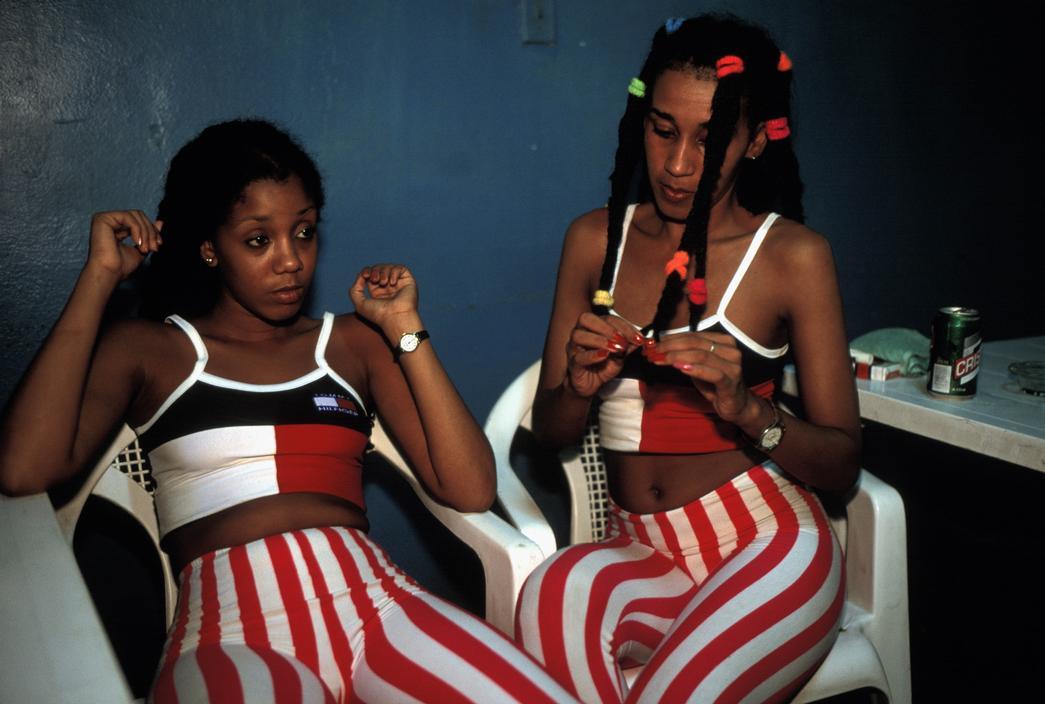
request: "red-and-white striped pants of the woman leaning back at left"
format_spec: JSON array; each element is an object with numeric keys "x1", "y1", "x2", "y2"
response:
[{"x1": 149, "y1": 527, "x2": 575, "y2": 704}]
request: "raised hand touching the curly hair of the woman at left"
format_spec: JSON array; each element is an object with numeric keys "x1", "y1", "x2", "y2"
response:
[{"x1": 87, "y1": 210, "x2": 163, "y2": 281}]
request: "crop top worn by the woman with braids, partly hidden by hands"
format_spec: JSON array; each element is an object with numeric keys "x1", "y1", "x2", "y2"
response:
[{"x1": 599, "y1": 205, "x2": 788, "y2": 454}]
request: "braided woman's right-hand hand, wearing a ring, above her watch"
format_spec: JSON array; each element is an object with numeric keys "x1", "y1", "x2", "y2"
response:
[{"x1": 647, "y1": 332, "x2": 754, "y2": 423}]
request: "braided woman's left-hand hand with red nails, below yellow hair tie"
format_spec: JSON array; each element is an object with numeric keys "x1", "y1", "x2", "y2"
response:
[{"x1": 565, "y1": 312, "x2": 645, "y2": 398}]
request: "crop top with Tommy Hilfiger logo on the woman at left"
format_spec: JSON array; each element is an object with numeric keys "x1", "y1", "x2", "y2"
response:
[{"x1": 135, "y1": 313, "x2": 373, "y2": 536}]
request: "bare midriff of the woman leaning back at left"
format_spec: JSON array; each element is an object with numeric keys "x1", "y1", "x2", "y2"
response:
[{"x1": 163, "y1": 493, "x2": 370, "y2": 574}]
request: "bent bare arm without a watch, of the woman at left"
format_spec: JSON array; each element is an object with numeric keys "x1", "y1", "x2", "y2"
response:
[{"x1": 0, "y1": 211, "x2": 160, "y2": 494}]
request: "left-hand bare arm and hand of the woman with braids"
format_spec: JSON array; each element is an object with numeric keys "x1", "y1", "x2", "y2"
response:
[{"x1": 533, "y1": 210, "x2": 641, "y2": 448}]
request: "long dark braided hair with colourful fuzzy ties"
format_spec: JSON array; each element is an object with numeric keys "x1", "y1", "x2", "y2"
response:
[{"x1": 595, "y1": 15, "x2": 804, "y2": 336}]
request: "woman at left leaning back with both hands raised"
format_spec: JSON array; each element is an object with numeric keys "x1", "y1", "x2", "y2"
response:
[{"x1": 0, "y1": 120, "x2": 571, "y2": 704}]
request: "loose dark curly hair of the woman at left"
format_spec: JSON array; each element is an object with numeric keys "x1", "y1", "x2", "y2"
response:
[{"x1": 139, "y1": 119, "x2": 324, "y2": 320}]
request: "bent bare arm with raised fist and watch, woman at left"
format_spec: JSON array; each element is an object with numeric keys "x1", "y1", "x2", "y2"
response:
[{"x1": 351, "y1": 264, "x2": 496, "y2": 511}]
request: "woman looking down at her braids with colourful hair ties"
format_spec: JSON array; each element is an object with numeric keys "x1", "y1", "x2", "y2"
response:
[{"x1": 516, "y1": 16, "x2": 860, "y2": 702}]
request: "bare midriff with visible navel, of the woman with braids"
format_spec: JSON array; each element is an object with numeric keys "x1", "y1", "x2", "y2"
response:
[{"x1": 603, "y1": 449, "x2": 765, "y2": 514}]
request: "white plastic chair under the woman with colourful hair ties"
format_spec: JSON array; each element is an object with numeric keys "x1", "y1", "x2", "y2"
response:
[{"x1": 486, "y1": 361, "x2": 911, "y2": 704}]
